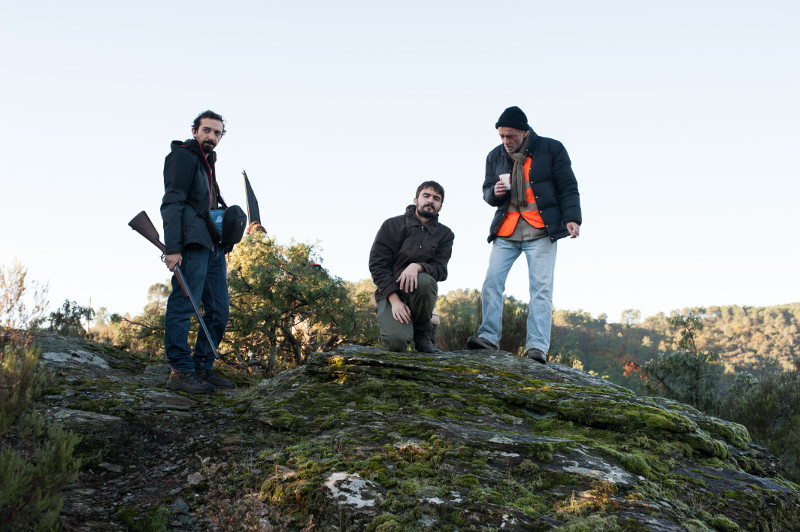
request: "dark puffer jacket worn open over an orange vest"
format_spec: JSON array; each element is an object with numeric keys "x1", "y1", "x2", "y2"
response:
[{"x1": 483, "y1": 129, "x2": 582, "y2": 242}]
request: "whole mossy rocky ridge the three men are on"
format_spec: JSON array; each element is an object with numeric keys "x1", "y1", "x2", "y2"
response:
[{"x1": 31, "y1": 337, "x2": 800, "y2": 531}]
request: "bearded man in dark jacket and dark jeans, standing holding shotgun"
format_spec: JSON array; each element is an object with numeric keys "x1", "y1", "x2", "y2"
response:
[{"x1": 161, "y1": 111, "x2": 235, "y2": 394}]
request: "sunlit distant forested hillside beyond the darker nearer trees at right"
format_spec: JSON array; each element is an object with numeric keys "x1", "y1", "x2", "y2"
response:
[{"x1": 436, "y1": 290, "x2": 800, "y2": 388}]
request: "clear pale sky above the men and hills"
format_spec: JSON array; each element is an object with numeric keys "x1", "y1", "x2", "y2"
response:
[{"x1": 0, "y1": 0, "x2": 800, "y2": 321}]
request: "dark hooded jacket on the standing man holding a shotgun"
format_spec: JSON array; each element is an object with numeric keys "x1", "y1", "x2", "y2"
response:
[{"x1": 161, "y1": 139, "x2": 219, "y2": 255}]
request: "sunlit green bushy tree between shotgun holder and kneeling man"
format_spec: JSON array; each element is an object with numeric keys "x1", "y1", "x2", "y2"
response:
[{"x1": 227, "y1": 233, "x2": 361, "y2": 373}]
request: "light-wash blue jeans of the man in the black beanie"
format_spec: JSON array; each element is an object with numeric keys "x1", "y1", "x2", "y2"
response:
[{"x1": 478, "y1": 237, "x2": 556, "y2": 353}]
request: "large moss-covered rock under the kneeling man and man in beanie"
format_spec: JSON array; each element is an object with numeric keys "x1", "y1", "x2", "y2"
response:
[{"x1": 242, "y1": 347, "x2": 800, "y2": 530}]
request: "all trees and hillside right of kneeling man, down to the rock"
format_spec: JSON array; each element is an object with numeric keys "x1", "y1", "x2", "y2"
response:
[{"x1": 437, "y1": 300, "x2": 800, "y2": 481}]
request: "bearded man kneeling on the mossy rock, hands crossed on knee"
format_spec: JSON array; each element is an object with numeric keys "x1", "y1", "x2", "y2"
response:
[{"x1": 369, "y1": 181, "x2": 454, "y2": 353}]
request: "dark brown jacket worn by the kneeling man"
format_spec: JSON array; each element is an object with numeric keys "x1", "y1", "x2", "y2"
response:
[{"x1": 369, "y1": 205, "x2": 455, "y2": 302}]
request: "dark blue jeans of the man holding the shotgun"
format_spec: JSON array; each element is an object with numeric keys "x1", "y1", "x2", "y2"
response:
[{"x1": 164, "y1": 247, "x2": 230, "y2": 371}]
